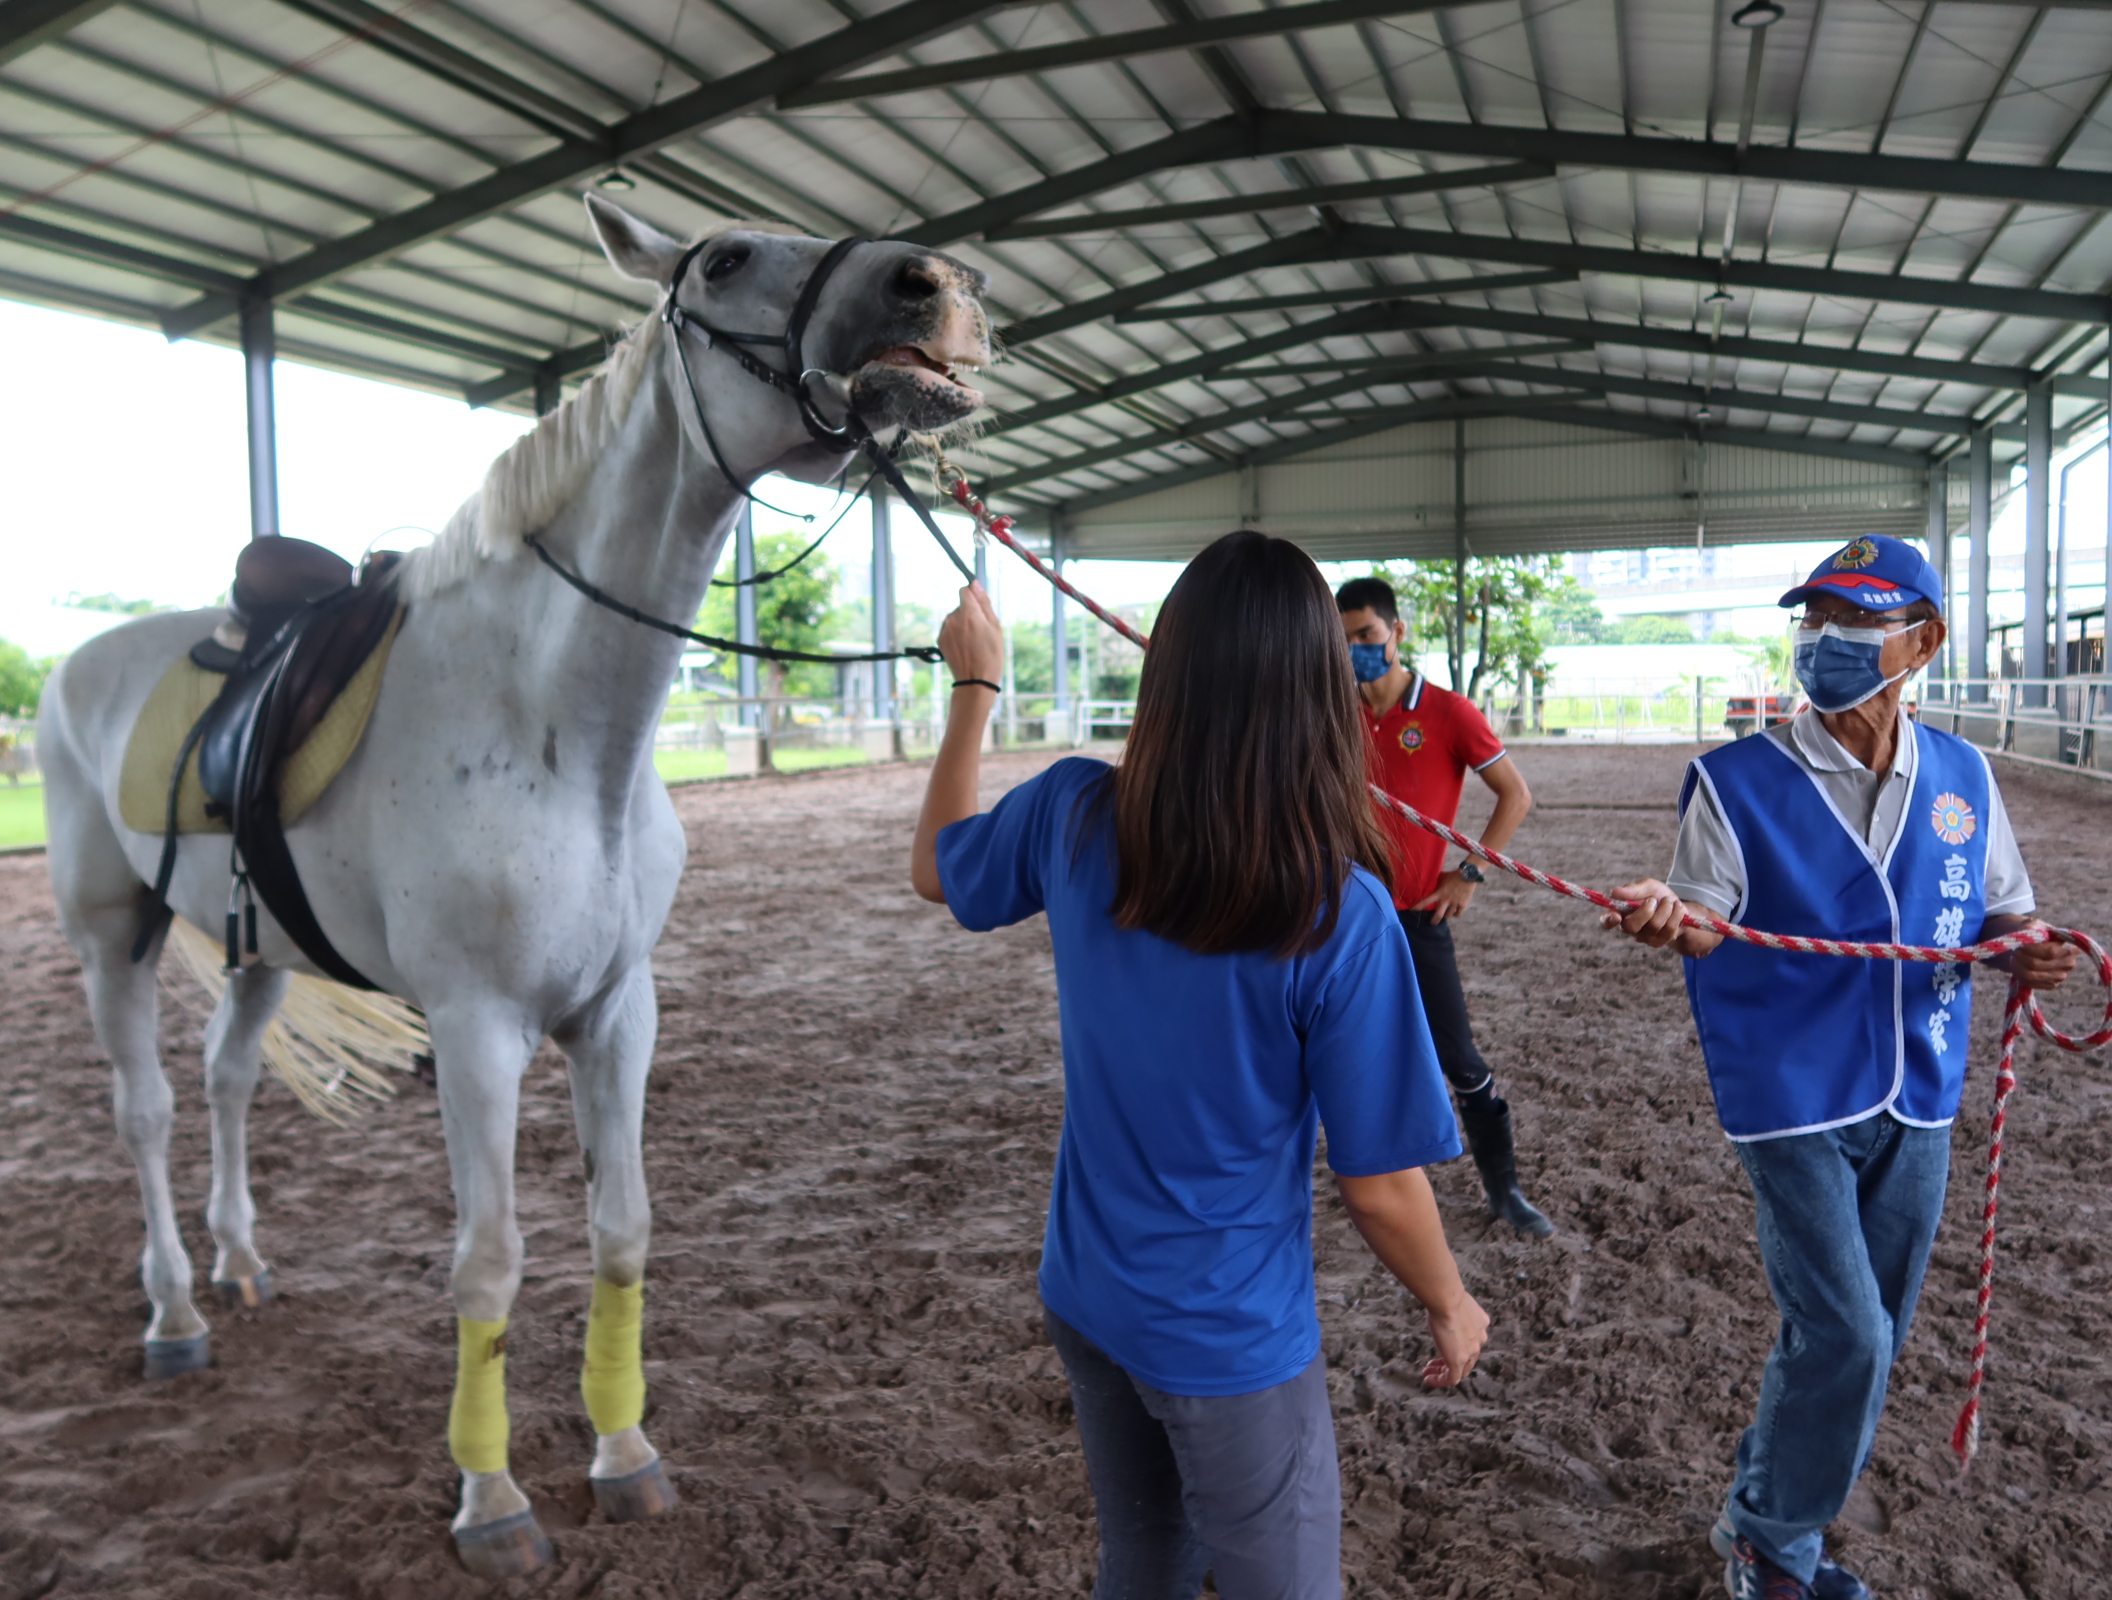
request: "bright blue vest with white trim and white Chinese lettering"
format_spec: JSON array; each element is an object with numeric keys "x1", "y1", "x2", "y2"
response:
[{"x1": 1679, "y1": 726, "x2": 1994, "y2": 1140}]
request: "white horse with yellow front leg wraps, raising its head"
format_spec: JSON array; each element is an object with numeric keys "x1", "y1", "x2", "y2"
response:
[{"x1": 38, "y1": 196, "x2": 988, "y2": 1577}]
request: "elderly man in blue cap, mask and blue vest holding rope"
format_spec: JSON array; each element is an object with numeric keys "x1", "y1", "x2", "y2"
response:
[{"x1": 1605, "y1": 536, "x2": 2076, "y2": 1600}]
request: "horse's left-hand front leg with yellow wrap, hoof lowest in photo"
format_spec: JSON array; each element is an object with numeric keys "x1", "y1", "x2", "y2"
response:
[{"x1": 427, "y1": 1003, "x2": 551, "y2": 1577}]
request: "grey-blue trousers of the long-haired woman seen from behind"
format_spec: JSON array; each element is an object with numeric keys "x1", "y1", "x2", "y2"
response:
[{"x1": 1041, "y1": 1309, "x2": 1341, "y2": 1600}]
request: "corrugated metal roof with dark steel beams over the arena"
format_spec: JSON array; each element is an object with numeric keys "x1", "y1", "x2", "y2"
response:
[{"x1": 0, "y1": 0, "x2": 2112, "y2": 540}]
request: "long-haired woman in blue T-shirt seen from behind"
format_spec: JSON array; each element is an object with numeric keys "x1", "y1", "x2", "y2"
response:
[{"x1": 910, "y1": 532, "x2": 1489, "y2": 1600}]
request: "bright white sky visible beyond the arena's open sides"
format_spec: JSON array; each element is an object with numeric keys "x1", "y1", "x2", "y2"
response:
[{"x1": 0, "y1": 302, "x2": 2106, "y2": 650}]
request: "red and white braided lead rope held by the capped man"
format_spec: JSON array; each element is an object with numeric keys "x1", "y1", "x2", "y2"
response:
[{"x1": 938, "y1": 456, "x2": 2112, "y2": 1469}]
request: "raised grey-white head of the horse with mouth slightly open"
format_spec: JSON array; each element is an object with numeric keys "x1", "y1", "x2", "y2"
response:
[{"x1": 587, "y1": 194, "x2": 991, "y2": 481}]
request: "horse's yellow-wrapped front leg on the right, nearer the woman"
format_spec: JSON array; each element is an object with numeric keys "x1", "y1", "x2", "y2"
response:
[{"x1": 555, "y1": 963, "x2": 676, "y2": 1522}]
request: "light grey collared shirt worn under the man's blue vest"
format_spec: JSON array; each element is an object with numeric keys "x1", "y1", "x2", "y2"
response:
[{"x1": 1664, "y1": 709, "x2": 2036, "y2": 916}]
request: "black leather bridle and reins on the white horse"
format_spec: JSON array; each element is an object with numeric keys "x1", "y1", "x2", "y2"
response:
[{"x1": 528, "y1": 236, "x2": 976, "y2": 665}]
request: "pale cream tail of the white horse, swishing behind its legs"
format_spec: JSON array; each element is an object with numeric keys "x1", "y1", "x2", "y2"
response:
[{"x1": 163, "y1": 916, "x2": 433, "y2": 1123}]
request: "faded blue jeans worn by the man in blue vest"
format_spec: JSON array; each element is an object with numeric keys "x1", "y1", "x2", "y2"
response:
[{"x1": 1730, "y1": 1115, "x2": 1951, "y2": 1583}]
